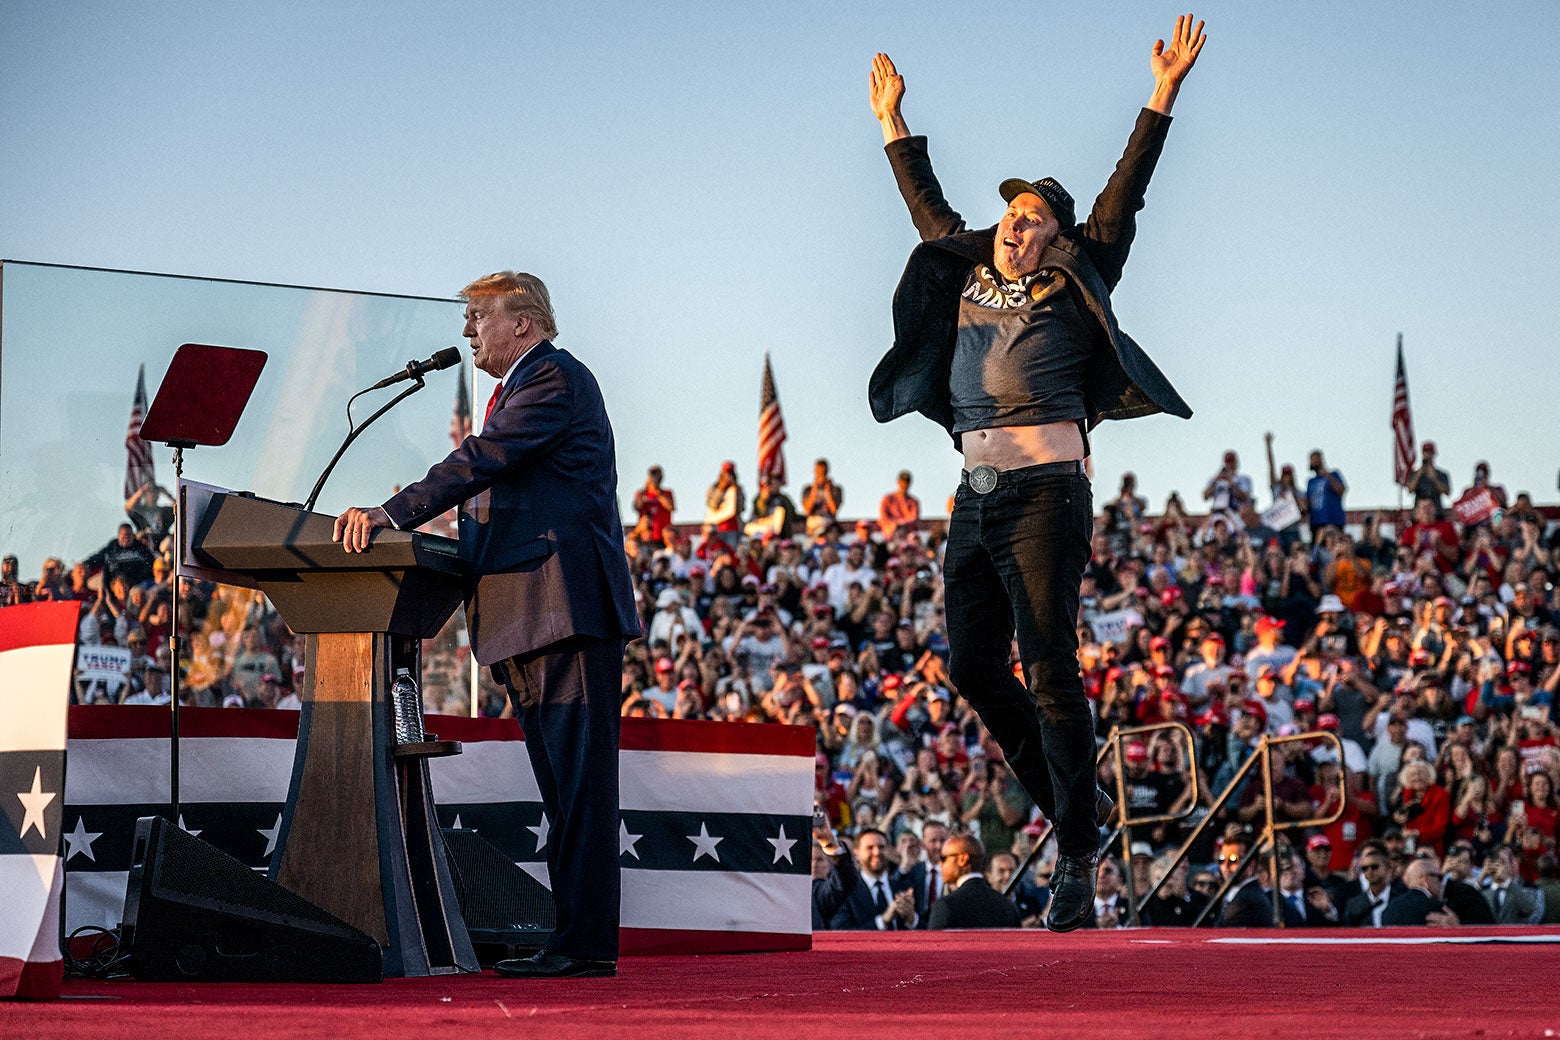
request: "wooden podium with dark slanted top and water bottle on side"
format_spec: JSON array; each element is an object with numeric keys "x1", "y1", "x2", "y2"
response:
[{"x1": 179, "y1": 483, "x2": 479, "y2": 976}]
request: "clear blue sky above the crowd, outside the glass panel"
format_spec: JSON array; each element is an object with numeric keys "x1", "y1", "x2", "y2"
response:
[{"x1": 0, "y1": 0, "x2": 1560, "y2": 536}]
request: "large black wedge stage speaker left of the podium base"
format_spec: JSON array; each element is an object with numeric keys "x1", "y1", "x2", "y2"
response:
[{"x1": 120, "y1": 817, "x2": 382, "y2": 982}]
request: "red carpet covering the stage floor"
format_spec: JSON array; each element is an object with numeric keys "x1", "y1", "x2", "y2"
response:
[{"x1": 0, "y1": 928, "x2": 1560, "y2": 1040}]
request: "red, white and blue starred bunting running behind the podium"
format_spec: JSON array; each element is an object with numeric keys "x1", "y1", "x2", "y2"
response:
[{"x1": 61, "y1": 706, "x2": 814, "y2": 953}]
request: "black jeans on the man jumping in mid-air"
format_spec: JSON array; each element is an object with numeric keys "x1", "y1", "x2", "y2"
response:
[{"x1": 942, "y1": 472, "x2": 1098, "y2": 856}]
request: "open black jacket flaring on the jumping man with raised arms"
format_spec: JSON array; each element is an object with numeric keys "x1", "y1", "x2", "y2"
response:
[{"x1": 869, "y1": 109, "x2": 1192, "y2": 444}]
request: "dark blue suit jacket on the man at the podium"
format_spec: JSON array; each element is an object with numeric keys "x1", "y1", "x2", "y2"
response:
[{"x1": 384, "y1": 340, "x2": 640, "y2": 664}]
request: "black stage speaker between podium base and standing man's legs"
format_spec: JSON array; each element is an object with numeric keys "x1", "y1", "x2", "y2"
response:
[{"x1": 443, "y1": 828, "x2": 557, "y2": 953}]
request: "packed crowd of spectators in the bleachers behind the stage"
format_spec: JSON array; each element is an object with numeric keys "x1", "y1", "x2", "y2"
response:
[{"x1": 12, "y1": 444, "x2": 1560, "y2": 928}]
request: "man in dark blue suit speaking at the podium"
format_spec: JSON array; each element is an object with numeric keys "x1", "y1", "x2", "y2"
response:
[{"x1": 335, "y1": 271, "x2": 640, "y2": 978}]
